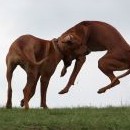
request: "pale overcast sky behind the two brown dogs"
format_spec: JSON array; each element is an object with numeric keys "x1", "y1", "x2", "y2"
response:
[{"x1": 0, "y1": 0, "x2": 130, "y2": 108}]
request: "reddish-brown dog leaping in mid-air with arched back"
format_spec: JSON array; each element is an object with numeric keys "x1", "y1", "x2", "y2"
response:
[{"x1": 58, "y1": 21, "x2": 130, "y2": 94}]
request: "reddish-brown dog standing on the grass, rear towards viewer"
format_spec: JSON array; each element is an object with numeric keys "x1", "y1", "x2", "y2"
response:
[{"x1": 6, "y1": 35, "x2": 62, "y2": 109}]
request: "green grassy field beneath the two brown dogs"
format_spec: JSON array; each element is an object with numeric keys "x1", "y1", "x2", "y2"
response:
[{"x1": 0, "y1": 107, "x2": 130, "y2": 130}]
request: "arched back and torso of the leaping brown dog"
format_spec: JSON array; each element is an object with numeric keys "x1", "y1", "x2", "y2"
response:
[{"x1": 61, "y1": 21, "x2": 129, "y2": 51}]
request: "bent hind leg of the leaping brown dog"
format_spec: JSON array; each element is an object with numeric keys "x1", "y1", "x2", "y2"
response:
[{"x1": 98, "y1": 54, "x2": 130, "y2": 93}]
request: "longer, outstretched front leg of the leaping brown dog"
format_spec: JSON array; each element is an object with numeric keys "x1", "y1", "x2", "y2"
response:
[{"x1": 59, "y1": 56, "x2": 86, "y2": 94}]
